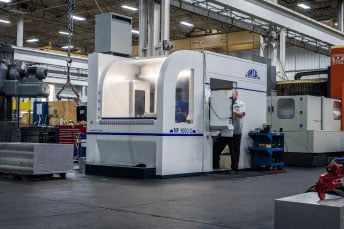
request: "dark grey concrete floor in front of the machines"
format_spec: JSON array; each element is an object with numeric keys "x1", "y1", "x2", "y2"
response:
[{"x1": 0, "y1": 167, "x2": 325, "y2": 229}]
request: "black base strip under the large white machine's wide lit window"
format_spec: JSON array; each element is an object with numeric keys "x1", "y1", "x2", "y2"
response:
[{"x1": 86, "y1": 164, "x2": 156, "y2": 179}]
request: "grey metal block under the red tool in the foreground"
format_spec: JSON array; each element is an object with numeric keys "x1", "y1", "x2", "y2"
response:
[{"x1": 275, "y1": 192, "x2": 344, "y2": 229}]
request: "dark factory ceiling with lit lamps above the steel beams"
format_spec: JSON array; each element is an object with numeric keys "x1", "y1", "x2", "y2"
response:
[{"x1": 0, "y1": 0, "x2": 337, "y2": 54}]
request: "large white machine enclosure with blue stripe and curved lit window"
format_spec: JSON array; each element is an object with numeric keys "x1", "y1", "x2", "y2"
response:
[{"x1": 86, "y1": 51, "x2": 267, "y2": 176}]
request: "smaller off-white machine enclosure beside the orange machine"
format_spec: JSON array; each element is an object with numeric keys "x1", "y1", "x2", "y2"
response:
[{"x1": 267, "y1": 95, "x2": 344, "y2": 153}]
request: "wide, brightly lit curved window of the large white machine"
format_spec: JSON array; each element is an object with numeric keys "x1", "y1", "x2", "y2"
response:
[{"x1": 101, "y1": 58, "x2": 165, "y2": 118}]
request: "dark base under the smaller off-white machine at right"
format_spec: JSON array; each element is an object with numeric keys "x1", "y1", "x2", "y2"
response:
[{"x1": 284, "y1": 152, "x2": 330, "y2": 167}]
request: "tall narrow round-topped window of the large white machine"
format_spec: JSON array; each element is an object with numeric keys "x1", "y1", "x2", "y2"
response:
[{"x1": 175, "y1": 69, "x2": 194, "y2": 124}]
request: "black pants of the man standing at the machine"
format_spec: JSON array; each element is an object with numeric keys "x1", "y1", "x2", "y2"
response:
[{"x1": 213, "y1": 134, "x2": 241, "y2": 171}]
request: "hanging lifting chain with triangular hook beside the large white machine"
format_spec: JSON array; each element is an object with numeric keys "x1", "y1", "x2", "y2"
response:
[{"x1": 56, "y1": 0, "x2": 80, "y2": 102}]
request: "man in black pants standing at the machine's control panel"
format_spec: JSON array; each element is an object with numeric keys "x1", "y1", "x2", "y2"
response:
[{"x1": 213, "y1": 89, "x2": 245, "y2": 175}]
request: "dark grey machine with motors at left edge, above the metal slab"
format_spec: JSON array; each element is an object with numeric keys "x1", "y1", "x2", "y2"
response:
[{"x1": 0, "y1": 44, "x2": 49, "y2": 142}]
